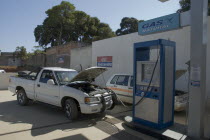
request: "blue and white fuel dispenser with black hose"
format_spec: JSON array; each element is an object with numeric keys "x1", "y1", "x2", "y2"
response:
[{"x1": 133, "y1": 39, "x2": 176, "y2": 129}]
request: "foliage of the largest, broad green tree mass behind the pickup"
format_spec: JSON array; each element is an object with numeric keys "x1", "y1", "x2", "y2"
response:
[{"x1": 34, "y1": 1, "x2": 114, "y2": 46}]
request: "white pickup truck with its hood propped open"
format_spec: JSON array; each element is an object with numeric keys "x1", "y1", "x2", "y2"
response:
[{"x1": 8, "y1": 67, "x2": 116, "y2": 119}]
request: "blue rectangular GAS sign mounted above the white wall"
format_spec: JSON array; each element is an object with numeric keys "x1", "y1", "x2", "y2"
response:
[{"x1": 138, "y1": 13, "x2": 180, "y2": 35}]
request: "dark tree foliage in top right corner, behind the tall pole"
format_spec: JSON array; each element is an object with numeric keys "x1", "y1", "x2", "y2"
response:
[{"x1": 177, "y1": 0, "x2": 210, "y2": 15}]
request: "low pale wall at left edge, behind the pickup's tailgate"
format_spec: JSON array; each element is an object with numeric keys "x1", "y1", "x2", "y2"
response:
[{"x1": 0, "y1": 73, "x2": 17, "y2": 90}]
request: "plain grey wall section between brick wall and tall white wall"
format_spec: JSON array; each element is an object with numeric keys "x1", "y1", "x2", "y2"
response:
[{"x1": 70, "y1": 46, "x2": 92, "y2": 71}]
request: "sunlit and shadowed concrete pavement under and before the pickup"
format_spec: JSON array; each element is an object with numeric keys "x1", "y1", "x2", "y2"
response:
[{"x1": 0, "y1": 90, "x2": 154, "y2": 140}]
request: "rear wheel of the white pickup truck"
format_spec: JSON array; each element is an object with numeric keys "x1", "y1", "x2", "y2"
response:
[{"x1": 17, "y1": 89, "x2": 29, "y2": 106}]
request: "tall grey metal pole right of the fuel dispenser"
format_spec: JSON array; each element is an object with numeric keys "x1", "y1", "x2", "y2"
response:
[{"x1": 188, "y1": 0, "x2": 208, "y2": 138}]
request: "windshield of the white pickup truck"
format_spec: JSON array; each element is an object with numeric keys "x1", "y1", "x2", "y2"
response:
[{"x1": 55, "y1": 71, "x2": 78, "y2": 85}]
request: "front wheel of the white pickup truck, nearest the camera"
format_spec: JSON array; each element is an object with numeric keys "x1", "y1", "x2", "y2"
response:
[{"x1": 65, "y1": 99, "x2": 79, "y2": 120}]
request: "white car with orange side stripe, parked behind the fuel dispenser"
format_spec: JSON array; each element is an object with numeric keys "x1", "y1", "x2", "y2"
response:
[{"x1": 106, "y1": 74, "x2": 189, "y2": 111}]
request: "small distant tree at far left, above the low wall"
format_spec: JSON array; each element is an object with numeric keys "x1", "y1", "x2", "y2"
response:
[{"x1": 14, "y1": 46, "x2": 28, "y2": 60}]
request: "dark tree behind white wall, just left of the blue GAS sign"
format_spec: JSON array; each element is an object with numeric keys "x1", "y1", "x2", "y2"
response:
[{"x1": 115, "y1": 17, "x2": 143, "y2": 36}]
